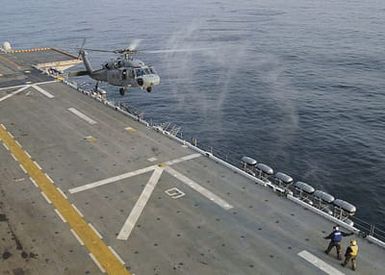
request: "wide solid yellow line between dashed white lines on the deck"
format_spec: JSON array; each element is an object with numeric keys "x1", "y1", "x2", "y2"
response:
[{"x1": 0, "y1": 127, "x2": 131, "y2": 275}]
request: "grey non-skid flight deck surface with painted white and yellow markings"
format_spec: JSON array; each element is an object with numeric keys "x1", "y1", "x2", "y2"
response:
[{"x1": 0, "y1": 50, "x2": 385, "y2": 274}]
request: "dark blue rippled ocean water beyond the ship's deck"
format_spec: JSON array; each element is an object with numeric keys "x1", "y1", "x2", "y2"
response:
[{"x1": 0, "y1": 0, "x2": 385, "y2": 231}]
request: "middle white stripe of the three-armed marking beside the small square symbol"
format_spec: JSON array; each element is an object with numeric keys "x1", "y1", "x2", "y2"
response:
[{"x1": 117, "y1": 167, "x2": 164, "y2": 240}]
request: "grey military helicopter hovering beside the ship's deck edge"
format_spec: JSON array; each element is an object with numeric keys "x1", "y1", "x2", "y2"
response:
[{"x1": 68, "y1": 42, "x2": 160, "y2": 96}]
